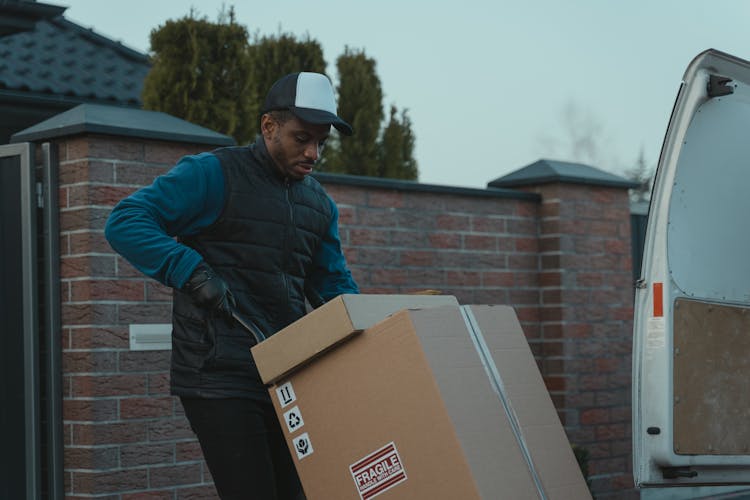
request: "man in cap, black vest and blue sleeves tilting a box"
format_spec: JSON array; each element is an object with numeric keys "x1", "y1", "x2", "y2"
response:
[{"x1": 105, "y1": 73, "x2": 358, "y2": 500}]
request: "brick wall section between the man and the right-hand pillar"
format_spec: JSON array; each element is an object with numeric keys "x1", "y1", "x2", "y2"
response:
[{"x1": 321, "y1": 176, "x2": 539, "y2": 331}]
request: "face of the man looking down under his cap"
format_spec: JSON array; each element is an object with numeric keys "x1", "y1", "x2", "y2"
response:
[{"x1": 260, "y1": 114, "x2": 331, "y2": 180}]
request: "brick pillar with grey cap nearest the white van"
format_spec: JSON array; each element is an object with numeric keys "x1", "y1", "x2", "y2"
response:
[{"x1": 491, "y1": 160, "x2": 633, "y2": 497}]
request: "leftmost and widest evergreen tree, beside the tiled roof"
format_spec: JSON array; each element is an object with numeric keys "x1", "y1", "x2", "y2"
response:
[{"x1": 142, "y1": 8, "x2": 257, "y2": 143}]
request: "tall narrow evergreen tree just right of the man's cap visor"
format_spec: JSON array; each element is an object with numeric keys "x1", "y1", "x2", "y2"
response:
[{"x1": 323, "y1": 47, "x2": 383, "y2": 176}]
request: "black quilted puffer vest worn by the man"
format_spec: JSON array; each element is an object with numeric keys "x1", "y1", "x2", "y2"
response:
[{"x1": 171, "y1": 138, "x2": 333, "y2": 398}]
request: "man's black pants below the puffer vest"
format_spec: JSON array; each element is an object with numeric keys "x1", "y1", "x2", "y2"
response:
[{"x1": 181, "y1": 398, "x2": 305, "y2": 500}]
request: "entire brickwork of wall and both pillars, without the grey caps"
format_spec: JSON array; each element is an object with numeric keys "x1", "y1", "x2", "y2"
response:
[{"x1": 58, "y1": 135, "x2": 632, "y2": 500}]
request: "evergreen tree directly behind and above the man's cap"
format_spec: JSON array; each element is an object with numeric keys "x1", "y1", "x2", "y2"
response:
[{"x1": 250, "y1": 33, "x2": 326, "y2": 134}]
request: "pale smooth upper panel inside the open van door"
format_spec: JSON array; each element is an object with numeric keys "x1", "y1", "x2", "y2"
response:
[{"x1": 667, "y1": 84, "x2": 750, "y2": 303}]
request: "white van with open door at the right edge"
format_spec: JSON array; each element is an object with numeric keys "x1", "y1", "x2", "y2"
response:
[{"x1": 633, "y1": 50, "x2": 750, "y2": 499}]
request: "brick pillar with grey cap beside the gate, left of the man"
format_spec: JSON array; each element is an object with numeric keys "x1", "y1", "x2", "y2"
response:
[{"x1": 11, "y1": 105, "x2": 231, "y2": 499}]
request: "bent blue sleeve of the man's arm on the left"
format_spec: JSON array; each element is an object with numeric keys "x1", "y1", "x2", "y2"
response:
[{"x1": 104, "y1": 153, "x2": 225, "y2": 288}]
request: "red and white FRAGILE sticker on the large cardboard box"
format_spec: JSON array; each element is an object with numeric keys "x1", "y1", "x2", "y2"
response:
[{"x1": 349, "y1": 442, "x2": 407, "y2": 500}]
